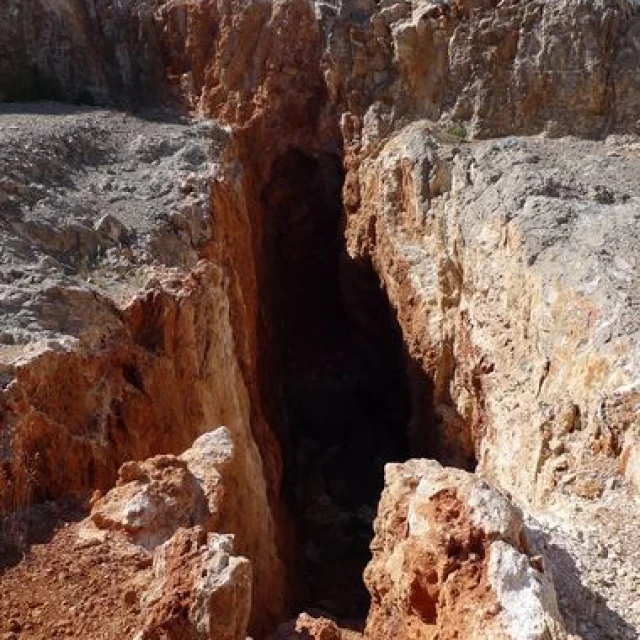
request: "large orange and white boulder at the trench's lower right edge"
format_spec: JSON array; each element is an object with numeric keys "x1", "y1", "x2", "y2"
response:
[{"x1": 365, "y1": 460, "x2": 567, "y2": 640}]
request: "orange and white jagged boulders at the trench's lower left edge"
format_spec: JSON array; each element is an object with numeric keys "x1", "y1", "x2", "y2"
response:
[{"x1": 79, "y1": 427, "x2": 260, "y2": 640}]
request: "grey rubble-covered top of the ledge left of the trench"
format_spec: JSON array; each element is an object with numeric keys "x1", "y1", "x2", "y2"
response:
[{"x1": 0, "y1": 103, "x2": 215, "y2": 340}]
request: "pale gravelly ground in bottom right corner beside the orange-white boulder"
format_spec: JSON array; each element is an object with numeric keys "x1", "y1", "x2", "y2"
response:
[{"x1": 529, "y1": 483, "x2": 640, "y2": 640}]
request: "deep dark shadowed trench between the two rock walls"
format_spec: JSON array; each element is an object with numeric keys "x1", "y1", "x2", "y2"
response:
[{"x1": 262, "y1": 150, "x2": 470, "y2": 620}]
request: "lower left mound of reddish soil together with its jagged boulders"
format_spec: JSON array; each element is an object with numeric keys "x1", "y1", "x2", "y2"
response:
[{"x1": 2, "y1": 427, "x2": 262, "y2": 640}]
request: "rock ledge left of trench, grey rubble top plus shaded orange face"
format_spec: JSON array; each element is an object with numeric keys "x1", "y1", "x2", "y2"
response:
[{"x1": 0, "y1": 106, "x2": 218, "y2": 503}]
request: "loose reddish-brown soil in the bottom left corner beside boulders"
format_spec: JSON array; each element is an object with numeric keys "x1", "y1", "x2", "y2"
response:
[{"x1": 0, "y1": 523, "x2": 151, "y2": 640}]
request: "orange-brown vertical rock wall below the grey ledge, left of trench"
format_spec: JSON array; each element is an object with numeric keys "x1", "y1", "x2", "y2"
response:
[{"x1": 1, "y1": 263, "x2": 285, "y2": 629}]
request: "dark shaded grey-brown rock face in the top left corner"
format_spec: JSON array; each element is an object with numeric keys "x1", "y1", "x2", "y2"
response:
[{"x1": 0, "y1": 0, "x2": 165, "y2": 104}]
